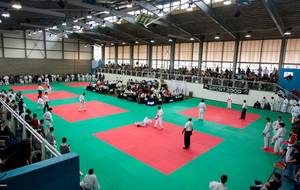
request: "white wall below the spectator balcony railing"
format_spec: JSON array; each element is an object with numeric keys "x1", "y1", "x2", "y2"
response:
[{"x1": 104, "y1": 73, "x2": 276, "y2": 107}]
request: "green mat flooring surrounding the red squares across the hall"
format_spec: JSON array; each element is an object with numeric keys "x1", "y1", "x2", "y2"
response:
[{"x1": 1, "y1": 83, "x2": 291, "y2": 190}]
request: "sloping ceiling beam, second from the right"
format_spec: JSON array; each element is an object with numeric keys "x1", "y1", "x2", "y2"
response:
[{"x1": 191, "y1": 1, "x2": 236, "y2": 39}]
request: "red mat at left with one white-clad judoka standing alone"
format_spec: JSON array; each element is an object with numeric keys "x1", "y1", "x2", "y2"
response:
[{"x1": 51, "y1": 99, "x2": 128, "y2": 122}]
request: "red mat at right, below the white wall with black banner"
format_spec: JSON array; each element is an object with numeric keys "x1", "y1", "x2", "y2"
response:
[{"x1": 177, "y1": 105, "x2": 261, "y2": 129}]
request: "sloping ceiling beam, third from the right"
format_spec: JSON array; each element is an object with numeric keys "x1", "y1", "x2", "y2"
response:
[{"x1": 135, "y1": 0, "x2": 198, "y2": 40}]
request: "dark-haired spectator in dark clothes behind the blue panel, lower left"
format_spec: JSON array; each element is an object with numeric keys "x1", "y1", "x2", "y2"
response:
[{"x1": 2, "y1": 139, "x2": 33, "y2": 172}]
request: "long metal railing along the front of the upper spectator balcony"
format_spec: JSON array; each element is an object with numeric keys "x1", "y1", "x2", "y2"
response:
[{"x1": 99, "y1": 68, "x2": 278, "y2": 92}]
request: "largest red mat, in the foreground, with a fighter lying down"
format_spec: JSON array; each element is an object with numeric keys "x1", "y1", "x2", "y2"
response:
[{"x1": 94, "y1": 121, "x2": 224, "y2": 175}]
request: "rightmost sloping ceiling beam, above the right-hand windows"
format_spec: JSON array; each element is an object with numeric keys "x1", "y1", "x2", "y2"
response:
[{"x1": 262, "y1": 0, "x2": 284, "y2": 36}]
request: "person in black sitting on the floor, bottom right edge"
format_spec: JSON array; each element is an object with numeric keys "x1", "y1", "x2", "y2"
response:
[{"x1": 250, "y1": 172, "x2": 281, "y2": 190}]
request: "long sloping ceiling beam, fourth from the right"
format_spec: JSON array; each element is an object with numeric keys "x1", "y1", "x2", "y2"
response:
[{"x1": 68, "y1": 1, "x2": 167, "y2": 40}]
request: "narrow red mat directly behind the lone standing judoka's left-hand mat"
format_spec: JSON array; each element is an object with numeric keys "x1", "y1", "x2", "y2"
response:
[{"x1": 23, "y1": 91, "x2": 80, "y2": 102}]
